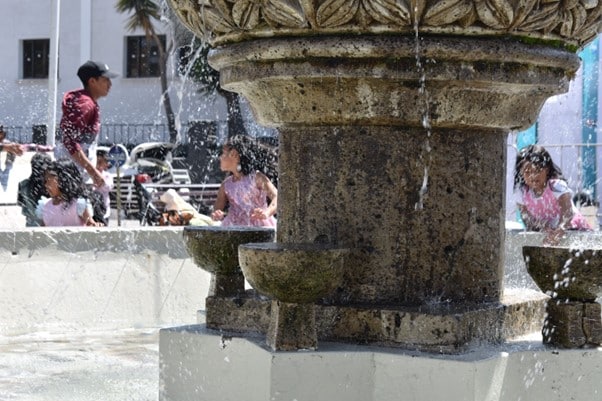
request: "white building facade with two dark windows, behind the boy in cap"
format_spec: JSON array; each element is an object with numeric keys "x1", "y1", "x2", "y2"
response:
[{"x1": 0, "y1": 0, "x2": 226, "y2": 142}]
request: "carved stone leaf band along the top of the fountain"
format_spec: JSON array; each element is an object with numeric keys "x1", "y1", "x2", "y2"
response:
[{"x1": 169, "y1": 0, "x2": 602, "y2": 49}]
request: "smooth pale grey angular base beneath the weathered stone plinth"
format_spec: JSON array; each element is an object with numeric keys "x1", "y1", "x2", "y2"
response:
[{"x1": 159, "y1": 325, "x2": 602, "y2": 401}]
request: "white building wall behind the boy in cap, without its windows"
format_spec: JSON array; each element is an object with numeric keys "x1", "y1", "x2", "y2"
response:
[{"x1": 0, "y1": 0, "x2": 226, "y2": 134}]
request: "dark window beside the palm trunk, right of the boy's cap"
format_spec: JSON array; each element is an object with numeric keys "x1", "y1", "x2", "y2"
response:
[{"x1": 126, "y1": 35, "x2": 165, "y2": 78}]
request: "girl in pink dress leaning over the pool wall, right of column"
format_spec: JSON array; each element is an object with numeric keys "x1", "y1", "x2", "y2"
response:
[{"x1": 514, "y1": 145, "x2": 592, "y2": 245}]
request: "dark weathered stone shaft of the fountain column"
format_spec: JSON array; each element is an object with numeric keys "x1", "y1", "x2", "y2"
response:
[{"x1": 278, "y1": 127, "x2": 505, "y2": 305}]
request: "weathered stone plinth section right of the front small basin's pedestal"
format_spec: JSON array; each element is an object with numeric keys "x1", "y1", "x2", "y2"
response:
[{"x1": 316, "y1": 288, "x2": 546, "y2": 353}]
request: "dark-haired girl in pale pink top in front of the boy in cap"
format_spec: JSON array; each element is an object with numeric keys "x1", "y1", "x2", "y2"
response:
[{"x1": 36, "y1": 159, "x2": 102, "y2": 227}]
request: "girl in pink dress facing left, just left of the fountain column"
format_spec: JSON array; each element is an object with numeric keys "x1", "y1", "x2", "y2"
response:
[{"x1": 211, "y1": 137, "x2": 278, "y2": 227}]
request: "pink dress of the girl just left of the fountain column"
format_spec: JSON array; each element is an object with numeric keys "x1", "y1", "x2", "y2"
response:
[{"x1": 222, "y1": 173, "x2": 276, "y2": 227}]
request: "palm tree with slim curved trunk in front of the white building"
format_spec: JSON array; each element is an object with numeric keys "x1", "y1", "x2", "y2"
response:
[{"x1": 115, "y1": 0, "x2": 178, "y2": 143}]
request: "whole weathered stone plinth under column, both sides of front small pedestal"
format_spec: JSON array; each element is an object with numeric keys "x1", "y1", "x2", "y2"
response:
[{"x1": 200, "y1": 289, "x2": 548, "y2": 353}]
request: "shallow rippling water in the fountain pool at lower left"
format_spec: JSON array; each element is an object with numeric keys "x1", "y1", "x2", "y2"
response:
[{"x1": 0, "y1": 328, "x2": 159, "y2": 401}]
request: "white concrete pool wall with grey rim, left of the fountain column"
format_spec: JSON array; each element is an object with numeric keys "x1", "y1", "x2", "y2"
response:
[{"x1": 0, "y1": 227, "x2": 210, "y2": 334}]
